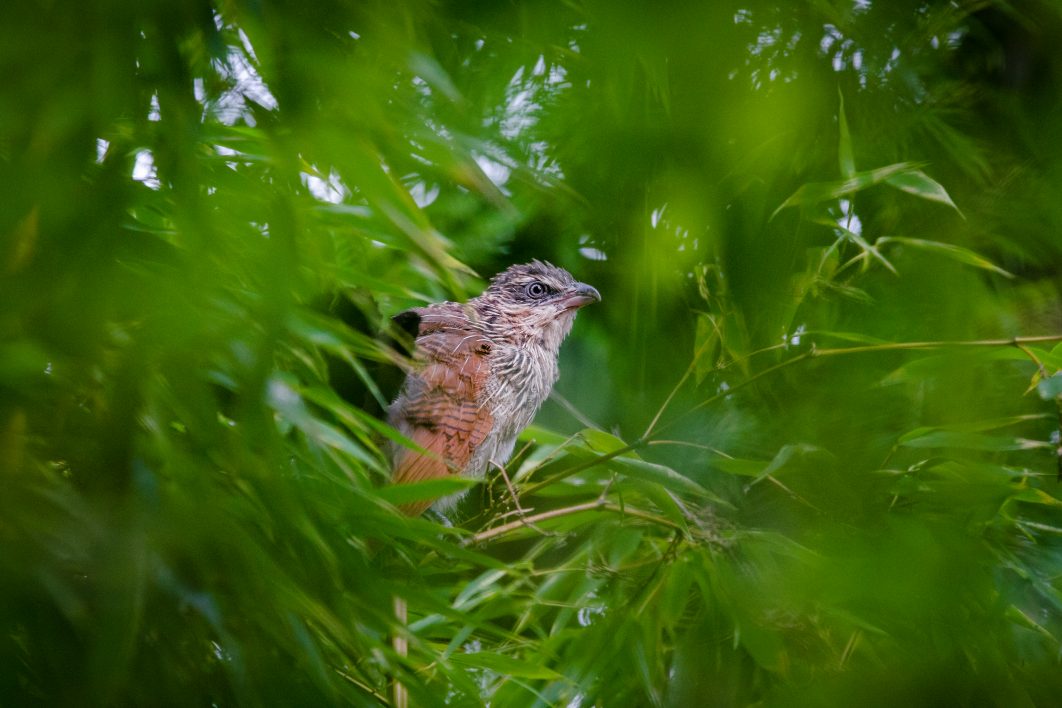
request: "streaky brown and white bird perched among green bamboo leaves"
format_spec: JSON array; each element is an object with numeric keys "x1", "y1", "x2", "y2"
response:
[{"x1": 388, "y1": 260, "x2": 601, "y2": 516}]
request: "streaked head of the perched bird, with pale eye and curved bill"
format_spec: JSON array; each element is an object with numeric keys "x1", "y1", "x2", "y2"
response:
[{"x1": 477, "y1": 260, "x2": 601, "y2": 350}]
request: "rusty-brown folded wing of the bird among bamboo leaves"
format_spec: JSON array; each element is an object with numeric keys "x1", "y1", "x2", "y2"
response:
[{"x1": 391, "y1": 303, "x2": 493, "y2": 515}]
